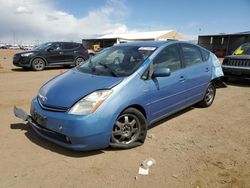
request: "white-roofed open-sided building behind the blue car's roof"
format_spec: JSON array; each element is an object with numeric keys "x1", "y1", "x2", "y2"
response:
[{"x1": 82, "y1": 30, "x2": 183, "y2": 51}]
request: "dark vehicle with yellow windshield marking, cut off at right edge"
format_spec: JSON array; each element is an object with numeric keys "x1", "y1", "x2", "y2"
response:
[{"x1": 222, "y1": 43, "x2": 250, "y2": 80}]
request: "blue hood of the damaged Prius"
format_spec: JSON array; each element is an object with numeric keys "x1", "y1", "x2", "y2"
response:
[{"x1": 38, "y1": 69, "x2": 123, "y2": 109}]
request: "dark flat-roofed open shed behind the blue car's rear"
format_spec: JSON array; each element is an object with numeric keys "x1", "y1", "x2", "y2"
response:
[{"x1": 198, "y1": 31, "x2": 250, "y2": 57}]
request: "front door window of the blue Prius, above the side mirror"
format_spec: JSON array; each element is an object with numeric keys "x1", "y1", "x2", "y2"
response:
[{"x1": 153, "y1": 46, "x2": 181, "y2": 72}]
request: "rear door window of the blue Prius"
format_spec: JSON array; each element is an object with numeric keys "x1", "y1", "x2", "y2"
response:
[{"x1": 182, "y1": 45, "x2": 203, "y2": 67}]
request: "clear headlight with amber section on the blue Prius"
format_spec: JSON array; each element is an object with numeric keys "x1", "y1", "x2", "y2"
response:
[{"x1": 69, "y1": 90, "x2": 112, "y2": 115}]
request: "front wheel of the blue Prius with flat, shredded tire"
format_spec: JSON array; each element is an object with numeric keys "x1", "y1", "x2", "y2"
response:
[{"x1": 110, "y1": 108, "x2": 147, "y2": 149}]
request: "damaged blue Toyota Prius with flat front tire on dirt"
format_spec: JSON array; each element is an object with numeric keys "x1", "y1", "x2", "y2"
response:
[{"x1": 14, "y1": 41, "x2": 220, "y2": 150}]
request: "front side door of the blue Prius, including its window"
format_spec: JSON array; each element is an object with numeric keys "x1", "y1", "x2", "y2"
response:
[{"x1": 146, "y1": 45, "x2": 186, "y2": 122}]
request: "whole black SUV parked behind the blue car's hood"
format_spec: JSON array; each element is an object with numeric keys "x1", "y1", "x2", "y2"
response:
[{"x1": 13, "y1": 42, "x2": 89, "y2": 71}]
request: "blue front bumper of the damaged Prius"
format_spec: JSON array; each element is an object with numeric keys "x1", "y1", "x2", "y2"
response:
[{"x1": 14, "y1": 99, "x2": 113, "y2": 151}]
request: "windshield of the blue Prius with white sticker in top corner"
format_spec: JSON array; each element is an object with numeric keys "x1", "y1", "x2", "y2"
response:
[{"x1": 77, "y1": 46, "x2": 156, "y2": 77}]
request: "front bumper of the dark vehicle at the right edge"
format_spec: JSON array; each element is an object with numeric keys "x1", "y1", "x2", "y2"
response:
[{"x1": 222, "y1": 65, "x2": 250, "y2": 78}]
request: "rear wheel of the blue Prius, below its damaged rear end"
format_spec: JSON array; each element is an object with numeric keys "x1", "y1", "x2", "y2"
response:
[{"x1": 199, "y1": 83, "x2": 216, "y2": 108}]
